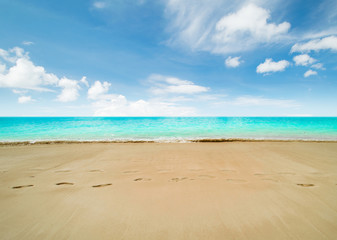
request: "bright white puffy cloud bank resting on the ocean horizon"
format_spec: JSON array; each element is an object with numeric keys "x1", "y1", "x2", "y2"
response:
[{"x1": 88, "y1": 79, "x2": 195, "y2": 116}]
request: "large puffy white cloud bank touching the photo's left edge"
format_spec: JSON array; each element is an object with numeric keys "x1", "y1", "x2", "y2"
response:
[{"x1": 0, "y1": 47, "x2": 88, "y2": 102}]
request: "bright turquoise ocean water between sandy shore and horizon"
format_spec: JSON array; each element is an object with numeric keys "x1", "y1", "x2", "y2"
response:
[{"x1": 0, "y1": 117, "x2": 337, "y2": 142}]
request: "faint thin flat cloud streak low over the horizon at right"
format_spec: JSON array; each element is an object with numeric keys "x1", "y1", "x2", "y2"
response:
[{"x1": 225, "y1": 96, "x2": 300, "y2": 108}]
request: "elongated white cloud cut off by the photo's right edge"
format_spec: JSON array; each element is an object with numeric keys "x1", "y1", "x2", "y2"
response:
[{"x1": 291, "y1": 36, "x2": 337, "y2": 52}]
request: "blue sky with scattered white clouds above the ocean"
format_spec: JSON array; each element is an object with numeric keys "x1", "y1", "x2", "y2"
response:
[{"x1": 0, "y1": 0, "x2": 337, "y2": 116}]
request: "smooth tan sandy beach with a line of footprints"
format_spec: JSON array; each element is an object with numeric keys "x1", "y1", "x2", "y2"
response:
[{"x1": 0, "y1": 142, "x2": 337, "y2": 239}]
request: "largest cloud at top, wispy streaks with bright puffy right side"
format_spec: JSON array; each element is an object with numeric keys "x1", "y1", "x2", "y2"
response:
[{"x1": 165, "y1": 0, "x2": 290, "y2": 54}]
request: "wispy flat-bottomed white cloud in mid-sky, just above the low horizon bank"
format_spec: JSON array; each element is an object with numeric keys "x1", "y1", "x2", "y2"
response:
[{"x1": 147, "y1": 74, "x2": 209, "y2": 94}]
